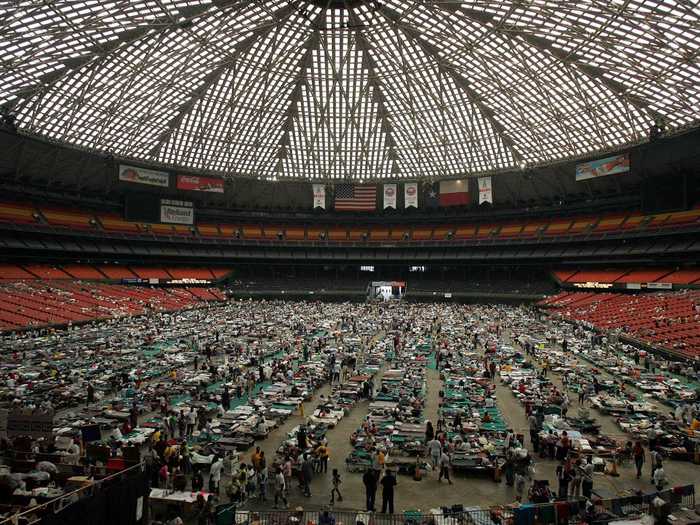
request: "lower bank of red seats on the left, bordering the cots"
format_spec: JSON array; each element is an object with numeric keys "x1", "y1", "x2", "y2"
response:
[{"x1": 0, "y1": 280, "x2": 224, "y2": 331}]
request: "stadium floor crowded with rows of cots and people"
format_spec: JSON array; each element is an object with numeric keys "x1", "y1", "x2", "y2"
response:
[{"x1": 2, "y1": 300, "x2": 700, "y2": 523}]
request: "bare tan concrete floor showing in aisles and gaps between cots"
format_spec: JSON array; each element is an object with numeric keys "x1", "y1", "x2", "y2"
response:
[{"x1": 198, "y1": 324, "x2": 700, "y2": 512}]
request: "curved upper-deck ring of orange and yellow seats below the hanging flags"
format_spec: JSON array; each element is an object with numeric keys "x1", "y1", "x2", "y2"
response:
[{"x1": 0, "y1": 202, "x2": 700, "y2": 243}]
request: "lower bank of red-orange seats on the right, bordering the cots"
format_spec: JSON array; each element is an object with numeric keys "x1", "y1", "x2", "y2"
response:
[{"x1": 538, "y1": 288, "x2": 700, "y2": 358}]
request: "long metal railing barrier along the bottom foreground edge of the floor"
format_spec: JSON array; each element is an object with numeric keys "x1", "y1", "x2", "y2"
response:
[{"x1": 216, "y1": 485, "x2": 695, "y2": 525}]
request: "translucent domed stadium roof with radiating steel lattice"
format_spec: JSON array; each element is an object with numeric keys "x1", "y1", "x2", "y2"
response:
[{"x1": 0, "y1": 0, "x2": 700, "y2": 180}]
